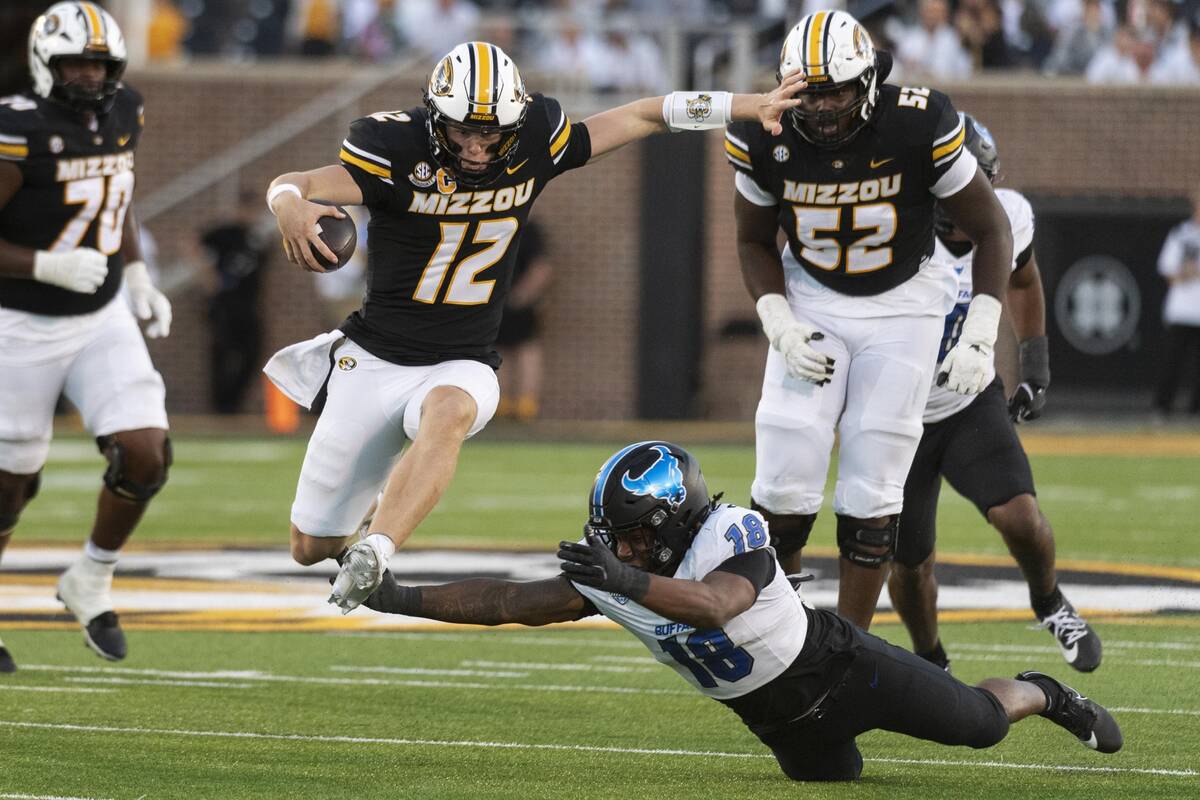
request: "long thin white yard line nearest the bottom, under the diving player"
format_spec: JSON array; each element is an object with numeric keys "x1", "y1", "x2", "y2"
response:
[{"x1": 0, "y1": 720, "x2": 1200, "y2": 777}]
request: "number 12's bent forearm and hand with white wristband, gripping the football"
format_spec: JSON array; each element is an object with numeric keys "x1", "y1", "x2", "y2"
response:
[{"x1": 266, "y1": 164, "x2": 362, "y2": 272}]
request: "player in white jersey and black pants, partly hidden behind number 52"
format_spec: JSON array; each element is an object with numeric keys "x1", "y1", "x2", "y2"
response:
[{"x1": 888, "y1": 114, "x2": 1100, "y2": 672}]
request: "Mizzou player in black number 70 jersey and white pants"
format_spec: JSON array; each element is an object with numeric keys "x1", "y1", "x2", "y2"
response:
[{"x1": 0, "y1": 2, "x2": 170, "y2": 672}]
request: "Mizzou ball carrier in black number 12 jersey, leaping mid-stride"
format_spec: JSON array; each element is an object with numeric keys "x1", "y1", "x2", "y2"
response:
[{"x1": 266, "y1": 42, "x2": 804, "y2": 612}]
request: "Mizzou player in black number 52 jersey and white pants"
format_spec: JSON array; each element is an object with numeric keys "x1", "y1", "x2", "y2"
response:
[{"x1": 725, "y1": 11, "x2": 1013, "y2": 628}]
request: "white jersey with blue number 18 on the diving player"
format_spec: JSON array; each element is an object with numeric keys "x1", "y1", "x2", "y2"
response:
[{"x1": 572, "y1": 505, "x2": 809, "y2": 700}]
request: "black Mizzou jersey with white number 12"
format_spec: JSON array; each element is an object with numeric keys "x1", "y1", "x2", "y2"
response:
[{"x1": 341, "y1": 95, "x2": 592, "y2": 367}]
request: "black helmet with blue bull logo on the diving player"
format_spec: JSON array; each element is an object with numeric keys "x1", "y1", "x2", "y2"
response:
[{"x1": 583, "y1": 441, "x2": 712, "y2": 575}]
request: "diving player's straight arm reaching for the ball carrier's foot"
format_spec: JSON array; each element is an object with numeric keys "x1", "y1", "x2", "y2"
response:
[{"x1": 362, "y1": 572, "x2": 587, "y2": 625}]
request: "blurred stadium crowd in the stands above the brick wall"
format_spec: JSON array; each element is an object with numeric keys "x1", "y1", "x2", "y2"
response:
[{"x1": 93, "y1": 0, "x2": 1200, "y2": 85}]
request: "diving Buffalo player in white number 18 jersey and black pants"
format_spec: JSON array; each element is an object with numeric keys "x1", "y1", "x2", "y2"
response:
[{"x1": 364, "y1": 441, "x2": 1122, "y2": 781}]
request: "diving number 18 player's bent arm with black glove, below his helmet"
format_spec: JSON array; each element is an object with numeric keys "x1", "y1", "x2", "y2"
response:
[{"x1": 558, "y1": 536, "x2": 758, "y2": 628}]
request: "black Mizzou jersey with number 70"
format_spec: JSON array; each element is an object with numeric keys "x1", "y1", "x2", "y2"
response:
[{"x1": 0, "y1": 85, "x2": 143, "y2": 317}]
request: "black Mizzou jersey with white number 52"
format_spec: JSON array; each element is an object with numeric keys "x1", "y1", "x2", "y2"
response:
[{"x1": 725, "y1": 84, "x2": 974, "y2": 296}]
